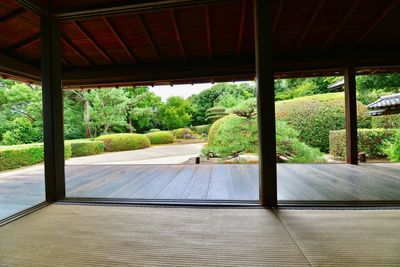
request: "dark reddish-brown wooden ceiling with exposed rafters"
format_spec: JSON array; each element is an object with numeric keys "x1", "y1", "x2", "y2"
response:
[{"x1": 0, "y1": 0, "x2": 400, "y2": 88}]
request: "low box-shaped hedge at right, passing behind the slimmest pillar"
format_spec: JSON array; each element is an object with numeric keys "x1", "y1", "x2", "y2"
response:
[{"x1": 329, "y1": 129, "x2": 400, "y2": 158}]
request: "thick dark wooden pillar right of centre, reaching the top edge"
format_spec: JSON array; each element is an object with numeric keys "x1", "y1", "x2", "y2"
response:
[{"x1": 254, "y1": 0, "x2": 277, "y2": 207}]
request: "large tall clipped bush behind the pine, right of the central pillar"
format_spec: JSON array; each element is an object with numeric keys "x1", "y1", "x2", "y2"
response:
[{"x1": 276, "y1": 93, "x2": 371, "y2": 152}]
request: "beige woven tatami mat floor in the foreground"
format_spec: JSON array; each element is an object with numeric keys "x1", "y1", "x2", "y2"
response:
[{"x1": 0, "y1": 204, "x2": 400, "y2": 266}]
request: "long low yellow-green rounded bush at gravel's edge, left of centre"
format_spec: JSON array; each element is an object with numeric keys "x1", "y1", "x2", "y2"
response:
[{"x1": 96, "y1": 133, "x2": 150, "y2": 152}]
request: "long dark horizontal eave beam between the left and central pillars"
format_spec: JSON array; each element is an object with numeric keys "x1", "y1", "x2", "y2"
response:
[{"x1": 63, "y1": 59, "x2": 255, "y2": 87}]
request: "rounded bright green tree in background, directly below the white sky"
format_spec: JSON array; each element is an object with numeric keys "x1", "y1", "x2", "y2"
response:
[{"x1": 160, "y1": 96, "x2": 192, "y2": 130}]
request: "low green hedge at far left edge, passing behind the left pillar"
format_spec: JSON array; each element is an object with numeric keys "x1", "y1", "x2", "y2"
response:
[{"x1": 0, "y1": 144, "x2": 71, "y2": 171}]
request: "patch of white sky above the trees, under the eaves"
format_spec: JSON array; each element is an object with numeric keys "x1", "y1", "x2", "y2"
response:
[{"x1": 149, "y1": 81, "x2": 254, "y2": 102}]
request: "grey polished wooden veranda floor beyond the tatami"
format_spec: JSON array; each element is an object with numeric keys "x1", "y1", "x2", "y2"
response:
[{"x1": 0, "y1": 163, "x2": 400, "y2": 219}]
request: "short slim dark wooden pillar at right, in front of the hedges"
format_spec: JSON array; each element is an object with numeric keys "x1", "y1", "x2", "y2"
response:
[{"x1": 344, "y1": 65, "x2": 358, "y2": 164}]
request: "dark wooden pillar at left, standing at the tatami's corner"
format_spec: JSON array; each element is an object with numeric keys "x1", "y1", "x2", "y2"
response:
[{"x1": 40, "y1": 15, "x2": 65, "y2": 202}]
